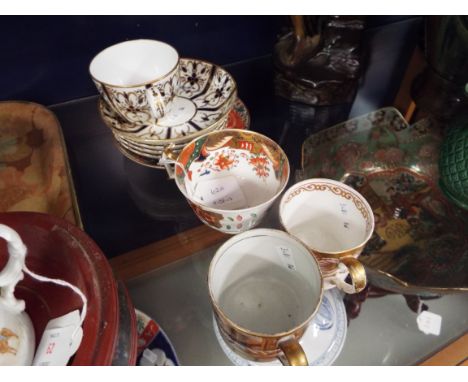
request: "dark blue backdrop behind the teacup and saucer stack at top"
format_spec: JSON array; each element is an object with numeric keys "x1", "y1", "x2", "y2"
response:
[{"x1": 0, "y1": 16, "x2": 416, "y2": 105}]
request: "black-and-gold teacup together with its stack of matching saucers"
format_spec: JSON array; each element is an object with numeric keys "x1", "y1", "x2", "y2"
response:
[{"x1": 89, "y1": 40, "x2": 237, "y2": 167}]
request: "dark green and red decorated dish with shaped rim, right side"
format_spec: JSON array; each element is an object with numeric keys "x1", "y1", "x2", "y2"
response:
[{"x1": 302, "y1": 108, "x2": 468, "y2": 295}]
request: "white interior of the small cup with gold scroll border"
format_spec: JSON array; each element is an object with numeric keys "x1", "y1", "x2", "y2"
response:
[{"x1": 280, "y1": 182, "x2": 373, "y2": 253}]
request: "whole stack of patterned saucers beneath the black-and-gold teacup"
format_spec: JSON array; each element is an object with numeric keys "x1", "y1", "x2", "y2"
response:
[{"x1": 98, "y1": 58, "x2": 250, "y2": 168}]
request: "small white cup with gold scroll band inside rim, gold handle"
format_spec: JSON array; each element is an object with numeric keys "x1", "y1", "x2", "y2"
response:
[{"x1": 280, "y1": 179, "x2": 374, "y2": 293}]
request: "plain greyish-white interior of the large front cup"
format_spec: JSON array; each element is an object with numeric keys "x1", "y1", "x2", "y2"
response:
[{"x1": 210, "y1": 230, "x2": 321, "y2": 335}]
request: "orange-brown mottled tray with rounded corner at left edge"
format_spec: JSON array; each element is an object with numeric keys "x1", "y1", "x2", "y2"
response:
[{"x1": 0, "y1": 101, "x2": 83, "y2": 228}]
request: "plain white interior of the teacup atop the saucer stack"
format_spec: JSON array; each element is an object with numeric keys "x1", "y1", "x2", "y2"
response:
[{"x1": 89, "y1": 40, "x2": 179, "y2": 87}]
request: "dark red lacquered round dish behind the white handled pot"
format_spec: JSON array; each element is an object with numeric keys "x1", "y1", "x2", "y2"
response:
[{"x1": 0, "y1": 212, "x2": 120, "y2": 365}]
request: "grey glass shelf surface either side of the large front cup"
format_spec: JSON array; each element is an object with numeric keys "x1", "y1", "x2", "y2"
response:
[{"x1": 128, "y1": 242, "x2": 468, "y2": 365}]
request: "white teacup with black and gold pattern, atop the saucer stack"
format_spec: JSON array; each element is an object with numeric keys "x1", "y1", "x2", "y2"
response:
[{"x1": 89, "y1": 40, "x2": 179, "y2": 124}]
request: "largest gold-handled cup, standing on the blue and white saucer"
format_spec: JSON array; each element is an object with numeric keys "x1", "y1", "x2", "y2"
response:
[{"x1": 208, "y1": 229, "x2": 323, "y2": 366}]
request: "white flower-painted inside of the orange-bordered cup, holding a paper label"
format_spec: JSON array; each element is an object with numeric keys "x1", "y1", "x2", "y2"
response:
[{"x1": 184, "y1": 147, "x2": 287, "y2": 210}]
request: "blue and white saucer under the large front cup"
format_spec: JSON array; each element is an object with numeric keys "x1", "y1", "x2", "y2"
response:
[{"x1": 213, "y1": 288, "x2": 347, "y2": 366}]
